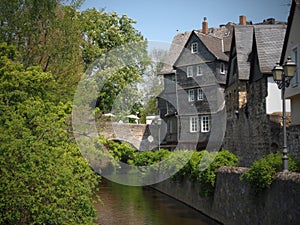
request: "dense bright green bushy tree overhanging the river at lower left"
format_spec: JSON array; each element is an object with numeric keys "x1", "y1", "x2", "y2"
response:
[{"x1": 0, "y1": 44, "x2": 98, "y2": 224}]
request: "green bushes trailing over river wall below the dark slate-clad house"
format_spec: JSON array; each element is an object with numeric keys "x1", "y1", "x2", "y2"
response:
[{"x1": 102, "y1": 135, "x2": 238, "y2": 196}]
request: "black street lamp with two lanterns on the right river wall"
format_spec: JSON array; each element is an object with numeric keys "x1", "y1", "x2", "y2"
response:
[{"x1": 272, "y1": 57, "x2": 297, "y2": 172}]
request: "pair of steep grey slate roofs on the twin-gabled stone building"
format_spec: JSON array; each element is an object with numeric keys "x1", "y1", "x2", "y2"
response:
[{"x1": 231, "y1": 24, "x2": 286, "y2": 80}]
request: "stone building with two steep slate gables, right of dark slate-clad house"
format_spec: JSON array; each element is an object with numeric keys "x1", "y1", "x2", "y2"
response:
[{"x1": 224, "y1": 20, "x2": 286, "y2": 166}]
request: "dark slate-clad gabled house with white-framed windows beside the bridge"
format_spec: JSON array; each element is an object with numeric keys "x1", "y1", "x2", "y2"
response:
[{"x1": 158, "y1": 18, "x2": 232, "y2": 150}]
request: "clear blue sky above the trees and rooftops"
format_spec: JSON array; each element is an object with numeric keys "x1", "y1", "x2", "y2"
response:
[{"x1": 81, "y1": 0, "x2": 290, "y2": 42}]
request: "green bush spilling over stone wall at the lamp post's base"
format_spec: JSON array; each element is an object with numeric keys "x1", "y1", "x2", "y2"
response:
[{"x1": 242, "y1": 152, "x2": 300, "y2": 194}]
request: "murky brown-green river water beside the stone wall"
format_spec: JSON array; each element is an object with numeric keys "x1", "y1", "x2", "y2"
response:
[{"x1": 96, "y1": 180, "x2": 218, "y2": 225}]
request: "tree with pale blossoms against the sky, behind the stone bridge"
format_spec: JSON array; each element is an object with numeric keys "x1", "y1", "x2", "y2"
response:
[{"x1": 81, "y1": 9, "x2": 149, "y2": 112}]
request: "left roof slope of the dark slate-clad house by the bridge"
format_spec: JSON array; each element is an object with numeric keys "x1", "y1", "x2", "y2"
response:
[{"x1": 159, "y1": 31, "x2": 192, "y2": 75}]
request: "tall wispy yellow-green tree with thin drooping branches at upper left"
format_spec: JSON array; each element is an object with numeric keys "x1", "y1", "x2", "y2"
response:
[{"x1": 0, "y1": 0, "x2": 83, "y2": 100}]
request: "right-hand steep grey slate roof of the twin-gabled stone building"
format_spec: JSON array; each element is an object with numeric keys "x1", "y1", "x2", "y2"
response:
[{"x1": 254, "y1": 24, "x2": 286, "y2": 74}]
